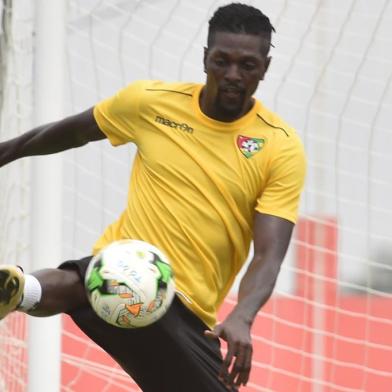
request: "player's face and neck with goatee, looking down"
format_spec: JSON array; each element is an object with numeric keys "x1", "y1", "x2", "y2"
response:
[{"x1": 201, "y1": 32, "x2": 270, "y2": 121}]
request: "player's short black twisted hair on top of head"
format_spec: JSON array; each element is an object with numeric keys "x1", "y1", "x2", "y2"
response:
[{"x1": 207, "y1": 3, "x2": 275, "y2": 55}]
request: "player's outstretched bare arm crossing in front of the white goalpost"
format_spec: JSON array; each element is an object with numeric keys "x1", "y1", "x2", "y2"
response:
[{"x1": 0, "y1": 108, "x2": 106, "y2": 167}]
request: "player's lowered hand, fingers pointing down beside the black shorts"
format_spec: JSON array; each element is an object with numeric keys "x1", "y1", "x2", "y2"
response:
[{"x1": 205, "y1": 315, "x2": 253, "y2": 388}]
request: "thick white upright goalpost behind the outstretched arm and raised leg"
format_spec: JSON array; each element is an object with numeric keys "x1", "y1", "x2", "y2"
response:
[{"x1": 27, "y1": 0, "x2": 67, "y2": 392}]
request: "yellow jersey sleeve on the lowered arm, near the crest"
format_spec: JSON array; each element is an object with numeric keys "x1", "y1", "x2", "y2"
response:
[{"x1": 256, "y1": 134, "x2": 306, "y2": 223}]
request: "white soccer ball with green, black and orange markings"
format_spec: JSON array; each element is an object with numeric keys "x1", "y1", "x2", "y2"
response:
[{"x1": 85, "y1": 240, "x2": 175, "y2": 328}]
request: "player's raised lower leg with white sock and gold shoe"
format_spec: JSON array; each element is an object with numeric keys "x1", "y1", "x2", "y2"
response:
[{"x1": 0, "y1": 265, "x2": 88, "y2": 319}]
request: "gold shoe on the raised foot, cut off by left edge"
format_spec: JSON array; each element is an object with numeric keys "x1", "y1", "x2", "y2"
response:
[{"x1": 0, "y1": 265, "x2": 25, "y2": 320}]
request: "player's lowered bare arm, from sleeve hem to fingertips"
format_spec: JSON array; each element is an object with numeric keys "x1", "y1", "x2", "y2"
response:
[{"x1": 206, "y1": 213, "x2": 294, "y2": 386}]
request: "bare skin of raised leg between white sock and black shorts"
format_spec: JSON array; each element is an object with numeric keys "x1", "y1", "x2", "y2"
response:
[{"x1": 28, "y1": 269, "x2": 89, "y2": 317}]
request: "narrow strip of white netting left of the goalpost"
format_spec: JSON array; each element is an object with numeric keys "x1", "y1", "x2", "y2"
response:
[{"x1": 0, "y1": 0, "x2": 33, "y2": 392}]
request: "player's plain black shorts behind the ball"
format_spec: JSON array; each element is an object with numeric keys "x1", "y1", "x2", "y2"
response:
[{"x1": 59, "y1": 257, "x2": 236, "y2": 392}]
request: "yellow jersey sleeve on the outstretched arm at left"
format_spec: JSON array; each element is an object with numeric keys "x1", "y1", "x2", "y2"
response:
[{"x1": 94, "y1": 81, "x2": 145, "y2": 146}]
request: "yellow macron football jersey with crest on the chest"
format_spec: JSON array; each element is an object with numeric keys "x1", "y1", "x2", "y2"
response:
[{"x1": 94, "y1": 81, "x2": 305, "y2": 327}]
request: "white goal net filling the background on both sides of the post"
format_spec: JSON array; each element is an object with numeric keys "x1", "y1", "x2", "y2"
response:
[{"x1": 0, "y1": 0, "x2": 392, "y2": 392}]
